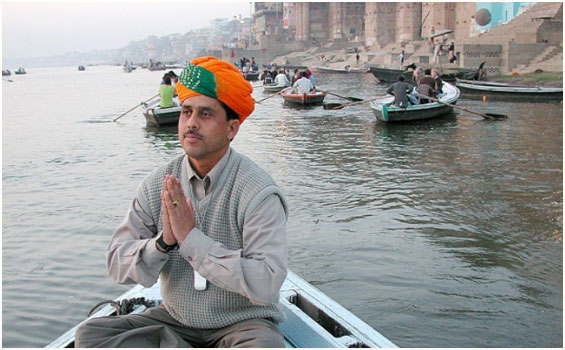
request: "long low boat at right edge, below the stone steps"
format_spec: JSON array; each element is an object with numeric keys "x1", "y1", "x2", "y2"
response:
[{"x1": 456, "y1": 80, "x2": 563, "y2": 102}]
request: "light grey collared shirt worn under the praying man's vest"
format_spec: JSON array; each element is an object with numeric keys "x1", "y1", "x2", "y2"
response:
[{"x1": 106, "y1": 149, "x2": 287, "y2": 305}]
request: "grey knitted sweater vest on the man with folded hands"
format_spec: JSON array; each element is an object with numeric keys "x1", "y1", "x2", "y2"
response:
[{"x1": 138, "y1": 149, "x2": 288, "y2": 329}]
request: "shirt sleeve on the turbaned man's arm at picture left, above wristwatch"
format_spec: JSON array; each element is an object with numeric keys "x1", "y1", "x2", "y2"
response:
[{"x1": 106, "y1": 194, "x2": 168, "y2": 287}]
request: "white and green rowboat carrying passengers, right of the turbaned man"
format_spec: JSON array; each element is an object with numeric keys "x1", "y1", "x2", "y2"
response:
[{"x1": 369, "y1": 83, "x2": 460, "y2": 123}]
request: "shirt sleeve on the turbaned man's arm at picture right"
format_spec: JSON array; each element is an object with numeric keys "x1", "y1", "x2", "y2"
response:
[{"x1": 180, "y1": 194, "x2": 287, "y2": 305}]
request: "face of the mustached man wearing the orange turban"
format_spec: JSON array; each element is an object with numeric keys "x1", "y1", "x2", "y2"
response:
[{"x1": 178, "y1": 95, "x2": 239, "y2": 160}]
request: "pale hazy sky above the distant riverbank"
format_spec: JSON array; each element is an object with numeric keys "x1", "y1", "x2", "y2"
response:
[{"x1": 1, "y1": 0, "x2": 251, "y2": 58}]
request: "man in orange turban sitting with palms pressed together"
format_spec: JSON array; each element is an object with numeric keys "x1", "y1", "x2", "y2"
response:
[{"x1": 75, "y1": 57, "x2": 288, "y2": 348}]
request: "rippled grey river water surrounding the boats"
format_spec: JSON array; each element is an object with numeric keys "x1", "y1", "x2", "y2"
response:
[{"x1": 2, "y1": 66, "x2": 563, "y2": 347}]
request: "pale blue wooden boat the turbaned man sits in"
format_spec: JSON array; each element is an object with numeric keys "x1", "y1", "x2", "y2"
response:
[{"x1": 46, "y1": 270, "x2": 397, "y2": 348}]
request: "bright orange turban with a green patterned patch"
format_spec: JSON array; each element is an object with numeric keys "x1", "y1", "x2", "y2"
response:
[{"x1": 176, "y1": 56, "x2": 255, "y2": 123}]
